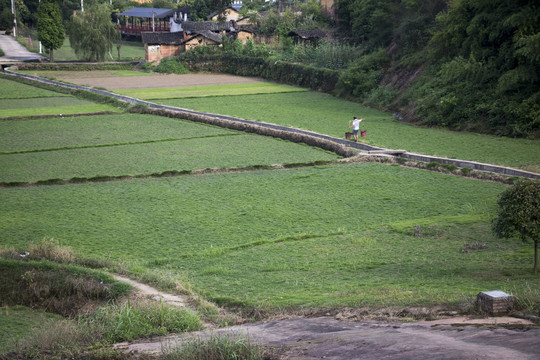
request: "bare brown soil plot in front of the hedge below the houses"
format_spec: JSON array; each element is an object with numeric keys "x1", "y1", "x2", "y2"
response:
[{"x1": 41, "y1": 71, "x2": 263, "y2": 90}]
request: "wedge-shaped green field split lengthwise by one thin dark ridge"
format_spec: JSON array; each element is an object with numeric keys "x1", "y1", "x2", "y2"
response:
[{"x1": 0, "y1": 114, "x2": 338, "y2": 182}]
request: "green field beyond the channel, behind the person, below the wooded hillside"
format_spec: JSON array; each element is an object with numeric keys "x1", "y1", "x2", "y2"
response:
[{"x1": 163, "y1": 92, "x2": 540, "y2": 172}]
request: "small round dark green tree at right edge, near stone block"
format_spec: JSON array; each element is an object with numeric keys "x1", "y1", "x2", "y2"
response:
[{"x1": 493, "y1": 180, "x2": 540, "y2": 274}]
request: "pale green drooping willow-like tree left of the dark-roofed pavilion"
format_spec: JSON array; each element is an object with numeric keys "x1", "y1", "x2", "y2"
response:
[{"x1": 68, "y1": 4, "x2": 120, "y2": 61}]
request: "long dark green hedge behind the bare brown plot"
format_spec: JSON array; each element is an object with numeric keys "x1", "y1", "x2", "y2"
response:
[{"x1": 180, "y1": 52, "x2": 340, "y2": 92}]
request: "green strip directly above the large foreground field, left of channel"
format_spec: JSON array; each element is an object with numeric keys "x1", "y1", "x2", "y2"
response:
[{"x1": 0, "y1": 134, "x2": 338, "y2": 182}]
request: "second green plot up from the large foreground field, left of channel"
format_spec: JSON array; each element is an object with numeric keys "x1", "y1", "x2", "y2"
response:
[{"x1": 0, "y1": 114, "x2": 235, "y2": 154}]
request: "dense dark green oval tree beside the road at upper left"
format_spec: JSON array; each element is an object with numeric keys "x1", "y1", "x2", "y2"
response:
[{"x1": 37, "y1": 0, "x2": 65, "y2": 62}]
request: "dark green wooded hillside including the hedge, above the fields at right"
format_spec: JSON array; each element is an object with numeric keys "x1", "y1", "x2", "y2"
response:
[{"x1": 181, "y1": 0, "x2": 540, "y2": 139}]
